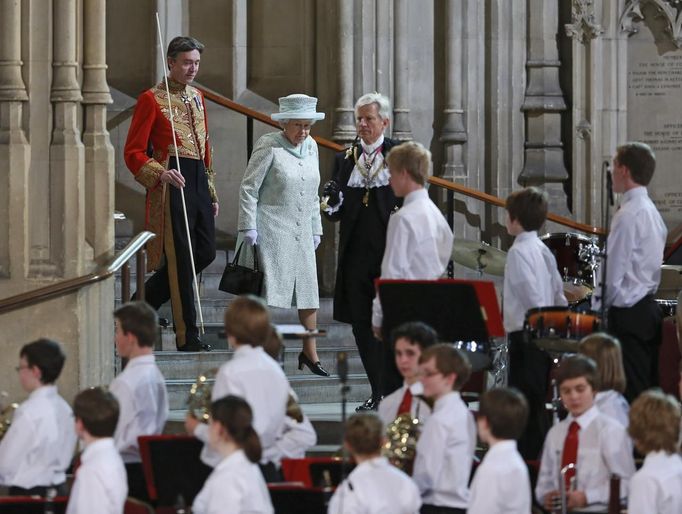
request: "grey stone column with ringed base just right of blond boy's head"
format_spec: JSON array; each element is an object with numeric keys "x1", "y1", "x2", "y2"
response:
[{"x1": 440, "y1": 0, "x2": 467, "y2": 181}]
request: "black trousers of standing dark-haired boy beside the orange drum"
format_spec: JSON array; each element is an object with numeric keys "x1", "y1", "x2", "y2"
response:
[{"x1": 508, "y1": 330, "x2": 551, "y2": 460}]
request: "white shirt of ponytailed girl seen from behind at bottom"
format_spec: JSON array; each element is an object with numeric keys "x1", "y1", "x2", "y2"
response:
[{"x1": 192, "y1": 450, "x2": 274, "y2": 514}]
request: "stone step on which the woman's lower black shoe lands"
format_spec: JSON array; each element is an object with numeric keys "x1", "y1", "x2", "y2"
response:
[{"x1": 166, "y1": 373, "x2": 370, "y2": 410}]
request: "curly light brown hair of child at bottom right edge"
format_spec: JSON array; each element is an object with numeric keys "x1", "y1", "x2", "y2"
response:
[{"x1": 628, "y1": 389, "x2": 680, "y2": 454}]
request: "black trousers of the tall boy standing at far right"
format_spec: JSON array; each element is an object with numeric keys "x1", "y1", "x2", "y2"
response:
[{"x1": 608, "y1": 295, "x2": 663, "y2": 402}]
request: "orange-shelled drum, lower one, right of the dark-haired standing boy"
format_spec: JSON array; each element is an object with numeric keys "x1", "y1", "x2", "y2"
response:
[{"x1": 525, "y1": 307, "x2": 600, "y2": 353}]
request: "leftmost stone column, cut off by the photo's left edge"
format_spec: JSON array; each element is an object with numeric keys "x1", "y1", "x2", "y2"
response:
[{"x1": 0, "y1": 0, "x2": 30, "y2": 279}]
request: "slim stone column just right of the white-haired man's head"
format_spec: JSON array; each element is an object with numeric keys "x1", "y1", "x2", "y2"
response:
[{"x1": 393, "y1": 0, "x2": 412, "y2": 141}]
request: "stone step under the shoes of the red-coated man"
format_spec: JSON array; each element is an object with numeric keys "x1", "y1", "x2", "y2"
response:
[{"x1": 155, "y1": 345, "x2": 364, "y2": 380}]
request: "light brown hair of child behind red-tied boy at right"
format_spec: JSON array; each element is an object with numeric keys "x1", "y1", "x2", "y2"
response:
[{"x1": 579, "y1": 332, "x2": 626, "y2": 393}]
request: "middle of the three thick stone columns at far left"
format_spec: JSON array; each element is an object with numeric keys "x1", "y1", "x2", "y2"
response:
[{"x1": 50, "y1": 0, "x2": 85, "y2": 277}]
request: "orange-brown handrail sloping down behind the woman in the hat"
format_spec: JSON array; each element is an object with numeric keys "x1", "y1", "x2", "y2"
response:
[{"x1": 195, "y1": 84, "x2": 606, "y2": 236}]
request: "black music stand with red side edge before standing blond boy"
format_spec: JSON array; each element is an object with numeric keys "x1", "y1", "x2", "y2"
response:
[{"x1": 377, "y1": 279, "x2": 496, "y2": 394}]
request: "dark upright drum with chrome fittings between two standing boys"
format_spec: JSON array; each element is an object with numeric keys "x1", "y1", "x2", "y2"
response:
[{"x1": 540, "y1": 233, "x2": 599, "y2": 303}]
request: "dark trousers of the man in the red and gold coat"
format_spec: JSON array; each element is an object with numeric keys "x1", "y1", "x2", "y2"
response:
[{"x1": 145, "y1": 157, "x2": 215, "y2": 346}]
